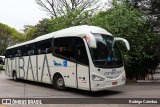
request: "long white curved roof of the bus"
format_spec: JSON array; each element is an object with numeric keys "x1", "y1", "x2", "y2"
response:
[{"x1": 7, "y1": 25, "x2": 112, "y2": 49}]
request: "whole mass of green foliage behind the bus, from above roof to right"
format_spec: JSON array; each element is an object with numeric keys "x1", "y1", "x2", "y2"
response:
[{"x1": 25, "y1": 0, "x2": 160, "y2": 79}]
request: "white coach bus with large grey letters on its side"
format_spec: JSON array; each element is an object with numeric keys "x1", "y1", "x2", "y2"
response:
[{"x1": 5, "y1": 25, "x2": 130, "y2": 91}]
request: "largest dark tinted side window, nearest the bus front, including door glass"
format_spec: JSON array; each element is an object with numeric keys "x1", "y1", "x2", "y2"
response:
[{"x1": 54, "y1": 37, "x2": 89, "y2": 65}]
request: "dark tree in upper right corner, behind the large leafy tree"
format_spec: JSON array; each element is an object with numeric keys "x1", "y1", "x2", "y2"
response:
[{"x1": 126, "y1": 0, "x2": 160, "y2": 32}]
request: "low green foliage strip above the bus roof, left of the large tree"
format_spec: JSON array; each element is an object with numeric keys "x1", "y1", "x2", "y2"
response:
[{"x1": 24, "y1": 10, "x2": 91, "y2": 40}]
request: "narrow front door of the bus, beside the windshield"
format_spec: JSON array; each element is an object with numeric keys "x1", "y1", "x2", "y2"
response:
[{"x1": 76, "y1": 39, "x2": 89, "y2": 89}]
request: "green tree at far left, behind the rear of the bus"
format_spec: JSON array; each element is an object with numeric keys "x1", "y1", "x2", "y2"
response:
[{"x1": 0, "y1": 23, "x2": 24, "y2": 55}]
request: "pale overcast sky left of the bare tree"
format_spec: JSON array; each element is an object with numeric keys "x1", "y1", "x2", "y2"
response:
[{"x1": 0, "y1": 0, "x2": 49, "y2": 32}]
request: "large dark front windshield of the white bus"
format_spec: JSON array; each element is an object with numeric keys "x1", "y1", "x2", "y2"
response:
[{"x1": 90, "y1": 34, "x2": 123, "y2": 68}]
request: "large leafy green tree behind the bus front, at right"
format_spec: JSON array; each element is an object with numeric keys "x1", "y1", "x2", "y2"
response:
[{"x1": 91, "y1": 0, "x2": 160, "y2": 79}]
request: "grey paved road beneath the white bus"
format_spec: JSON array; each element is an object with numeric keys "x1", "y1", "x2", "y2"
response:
[{"x1": 0, "y1": 71, "x2": 160, "y2": 107}]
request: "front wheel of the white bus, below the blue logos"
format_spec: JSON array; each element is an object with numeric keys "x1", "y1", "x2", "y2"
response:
[{"x1": 53, "y1": 74, "x2": 66, "y2": 91}]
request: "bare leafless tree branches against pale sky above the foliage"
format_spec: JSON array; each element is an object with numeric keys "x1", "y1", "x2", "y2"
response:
[{"x1": 36, "y1": 0, "x2": 100, "y2": 17}]
